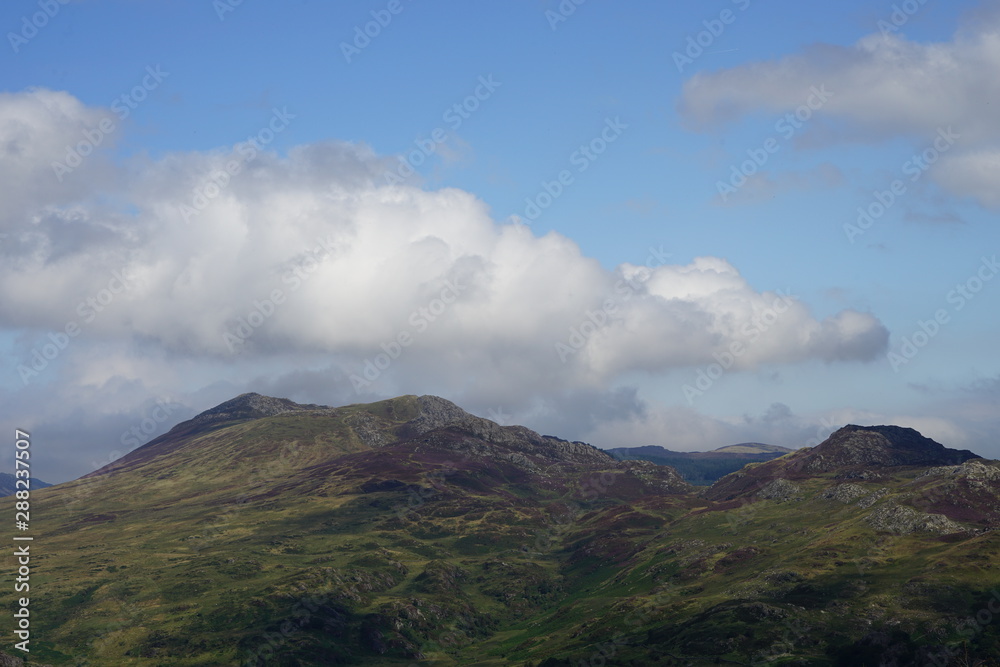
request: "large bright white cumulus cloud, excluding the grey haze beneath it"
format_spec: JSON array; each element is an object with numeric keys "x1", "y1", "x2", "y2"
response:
[{"x1": 0, "y1": 91, "x2": 885, "y2": 392}]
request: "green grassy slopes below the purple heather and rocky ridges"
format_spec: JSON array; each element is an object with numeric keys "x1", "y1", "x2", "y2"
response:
[{"x1": 7, "y1": 397, "x2": 1000, "y2": 667}]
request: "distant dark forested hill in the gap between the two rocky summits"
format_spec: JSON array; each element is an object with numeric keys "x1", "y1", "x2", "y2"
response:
[{"x1": 607, "y1": 442, "x2": 794, "y2": 486}]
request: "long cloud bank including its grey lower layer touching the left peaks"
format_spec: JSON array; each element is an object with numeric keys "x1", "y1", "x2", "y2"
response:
[{"x1": 0, "y1": 90, "x2": 900, "y2": 480}]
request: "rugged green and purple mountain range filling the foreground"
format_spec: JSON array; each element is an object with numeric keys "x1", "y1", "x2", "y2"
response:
[{"x1": 0, "y1": 394, "x2": 1000, "y2": 667}]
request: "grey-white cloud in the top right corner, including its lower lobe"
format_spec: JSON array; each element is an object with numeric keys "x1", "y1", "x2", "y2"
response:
[{"x1": 678, "y1": 12, "x2": 1000, "y2": 208}]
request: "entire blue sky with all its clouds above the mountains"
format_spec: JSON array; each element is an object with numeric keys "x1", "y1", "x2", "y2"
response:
[{"x1": 0, "y1": 0, "x2": 1000, "y2": 482}]
